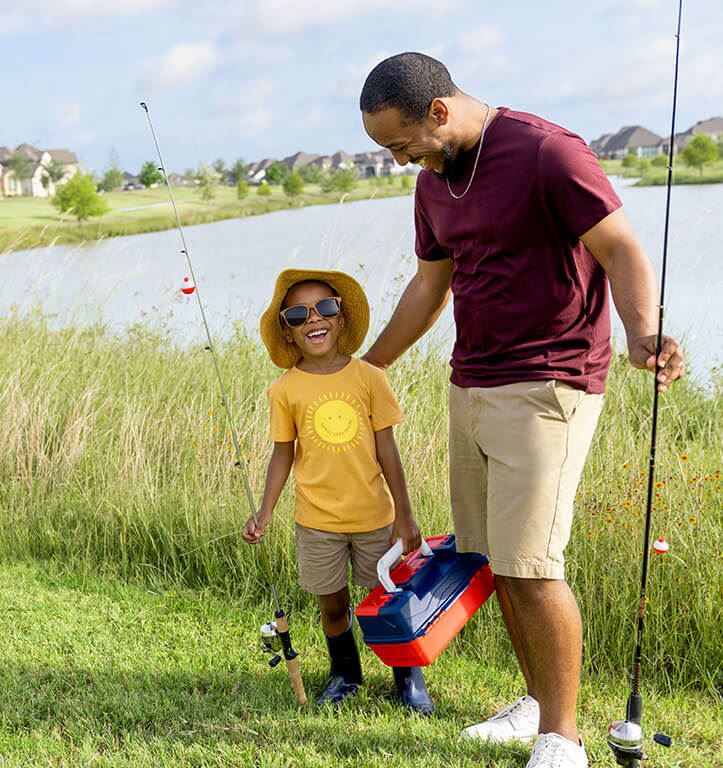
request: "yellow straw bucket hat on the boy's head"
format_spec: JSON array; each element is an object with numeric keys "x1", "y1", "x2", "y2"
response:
[{"x1": 259, "y1": 269, "x2": 369, "y2": 368}]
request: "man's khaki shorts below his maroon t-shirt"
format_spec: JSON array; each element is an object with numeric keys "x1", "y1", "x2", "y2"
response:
[{"x1": 449, "y1": 381, "x2": 603, "y2": 579}]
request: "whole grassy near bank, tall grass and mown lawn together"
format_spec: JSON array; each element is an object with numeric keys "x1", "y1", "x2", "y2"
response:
[{"x1": 0, "y1": 313, "x2": 723, "y2": 768}]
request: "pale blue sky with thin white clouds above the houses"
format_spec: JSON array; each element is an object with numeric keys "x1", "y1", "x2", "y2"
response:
[{"x1": 0, "y1": 0, "x2": 723, "y2": 174}]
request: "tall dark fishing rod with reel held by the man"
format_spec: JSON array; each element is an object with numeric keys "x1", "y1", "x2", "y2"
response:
[{"x1": 607, "y1": 0, "x2": 683, "y2": 768}]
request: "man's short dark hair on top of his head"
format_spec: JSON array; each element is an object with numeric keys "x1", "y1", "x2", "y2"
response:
[{"x1": 359, "y1": 53, "x2": 459, "y2": 123}]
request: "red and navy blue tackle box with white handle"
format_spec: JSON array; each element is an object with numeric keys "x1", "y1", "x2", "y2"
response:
[{"x1": 356, "y1": 535, "x2": 495, "y2": 667}]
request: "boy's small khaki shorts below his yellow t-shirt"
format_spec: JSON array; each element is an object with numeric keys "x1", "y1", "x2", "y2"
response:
[{"x1": 294, "y1": 523, "x2": 392, "y2": 595}]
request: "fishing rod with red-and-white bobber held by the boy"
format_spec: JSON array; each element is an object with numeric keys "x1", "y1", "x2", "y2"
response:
[{"x1": 140, "y1": 101, "x2": 306, "y2": 707}]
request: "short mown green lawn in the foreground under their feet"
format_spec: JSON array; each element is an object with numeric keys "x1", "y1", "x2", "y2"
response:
[{"x1": 0, "y1": 562, "x2": 723, "y2": 768}]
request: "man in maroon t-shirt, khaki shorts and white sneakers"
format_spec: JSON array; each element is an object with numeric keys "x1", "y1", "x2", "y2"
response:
[{"x1": 360, "y1": 53, "x2": 683, "y2": 768}]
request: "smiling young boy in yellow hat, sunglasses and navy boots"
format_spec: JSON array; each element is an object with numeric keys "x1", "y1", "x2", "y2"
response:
[{"x1": 243, "y1": 269, "x2": 434, "y2": 714}]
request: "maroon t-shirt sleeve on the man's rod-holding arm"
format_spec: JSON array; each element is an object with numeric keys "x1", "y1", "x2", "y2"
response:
[{"x1": 538, "y1": 133, "x2": 622, "y2": 238}]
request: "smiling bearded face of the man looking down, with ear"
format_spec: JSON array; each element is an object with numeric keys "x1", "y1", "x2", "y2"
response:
[{"x1": 362, "y1": 99, "x2": 459, "y2": 175}]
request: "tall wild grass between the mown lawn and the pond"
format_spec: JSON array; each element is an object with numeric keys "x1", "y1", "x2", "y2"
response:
[{"x1": 0, "y1": 308, "x2": 723, "y2": 691}]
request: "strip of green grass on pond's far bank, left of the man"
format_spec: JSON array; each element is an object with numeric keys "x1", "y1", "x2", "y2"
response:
[{"x1": 0, "y1": 177, "x2": 414, "y2": 252}]
